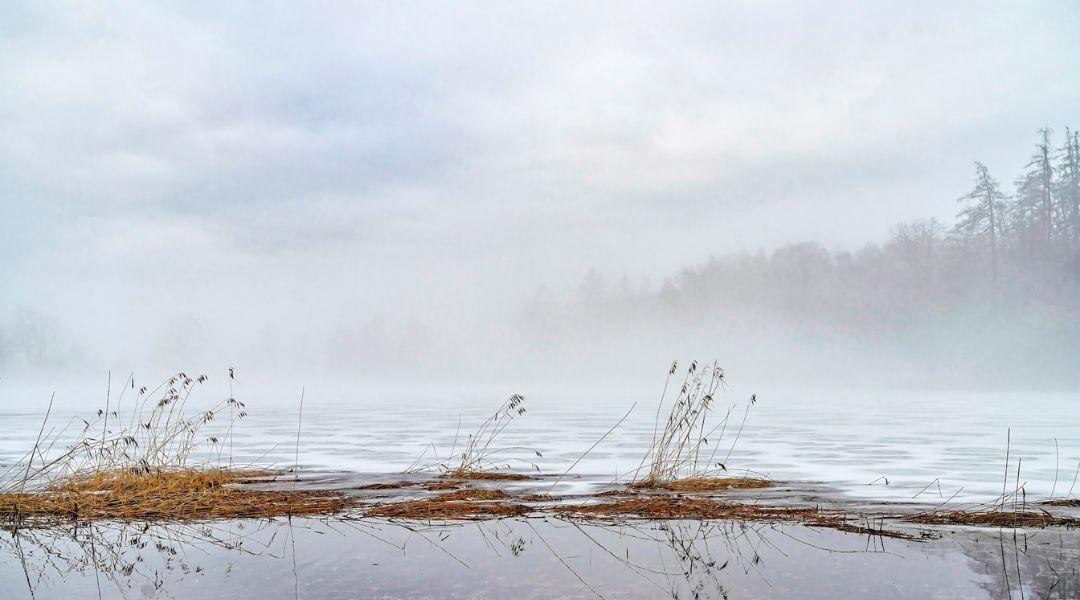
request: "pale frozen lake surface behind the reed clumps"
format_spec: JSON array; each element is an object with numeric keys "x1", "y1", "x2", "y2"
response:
[{"x1": 0, "y1": 384, "x2": 1080, "y2": 503}]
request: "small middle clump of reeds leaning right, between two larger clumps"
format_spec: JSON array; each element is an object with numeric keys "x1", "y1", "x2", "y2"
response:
[{"x1": 405, "y1": 394, "x2": 541, "y2": 479}]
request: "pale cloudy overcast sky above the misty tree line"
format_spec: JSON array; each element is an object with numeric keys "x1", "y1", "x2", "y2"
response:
[{"x1": 0, "y1": 1, "x2": 1080, "y2": 371}]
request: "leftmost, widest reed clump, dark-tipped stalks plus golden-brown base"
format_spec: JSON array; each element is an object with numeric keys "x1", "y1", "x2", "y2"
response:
[{"x1": 0, "y1": 369, "x2": 349, "y2": 528}]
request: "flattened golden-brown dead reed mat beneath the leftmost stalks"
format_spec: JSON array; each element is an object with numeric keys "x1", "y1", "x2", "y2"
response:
[{"x1": 0, "y1": 469, "x2": 351, "y2": 526}]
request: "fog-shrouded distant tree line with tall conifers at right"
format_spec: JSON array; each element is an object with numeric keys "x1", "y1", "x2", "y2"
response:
[{"x1": 526, "y1": 128, "x2": 1080, "y2": 332}]
